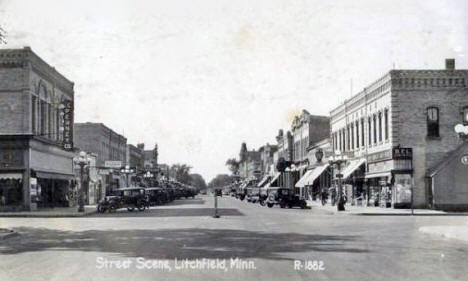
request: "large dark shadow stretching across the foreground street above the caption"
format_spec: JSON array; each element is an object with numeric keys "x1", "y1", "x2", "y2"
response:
[{"x1": 0, "y1": 227, "x2": 368, "y2": 260}]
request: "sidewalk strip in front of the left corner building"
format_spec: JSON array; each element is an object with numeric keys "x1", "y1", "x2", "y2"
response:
[{"x1": 0, "y1": 205, "x2": 97, "y2": 218}]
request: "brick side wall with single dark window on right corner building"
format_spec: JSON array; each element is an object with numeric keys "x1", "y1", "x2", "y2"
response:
[{"x1": 392, "y1": 82, "x2": 468, "y2": 207}]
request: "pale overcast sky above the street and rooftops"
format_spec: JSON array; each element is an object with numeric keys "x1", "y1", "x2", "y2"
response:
[{"x1": 0, "y1": 0, "x2": 468, "y2": 180}]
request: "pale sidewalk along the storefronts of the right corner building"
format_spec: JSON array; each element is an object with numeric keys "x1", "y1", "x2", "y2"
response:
[{"x1": 307, "y1": 201, "x2": 468, "y2": 216}]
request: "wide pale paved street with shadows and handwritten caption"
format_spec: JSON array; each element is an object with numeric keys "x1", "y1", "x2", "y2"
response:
[{"x1": 0, "y1": 196, "x2": 468, "y2": 281}]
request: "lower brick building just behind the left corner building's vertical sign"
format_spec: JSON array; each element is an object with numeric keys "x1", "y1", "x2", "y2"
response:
[{"x1": 74, "y1": 122, "x2": 127, "y2": 193}]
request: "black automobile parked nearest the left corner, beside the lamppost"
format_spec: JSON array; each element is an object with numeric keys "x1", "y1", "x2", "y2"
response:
[{"x1": 97, "y1": 187, "x2": 148, "y2": 213}]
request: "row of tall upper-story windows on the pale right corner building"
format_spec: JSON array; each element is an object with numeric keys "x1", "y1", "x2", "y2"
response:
[{"x1": 332, "y1": 109, "x2": 390, "y2": 151}]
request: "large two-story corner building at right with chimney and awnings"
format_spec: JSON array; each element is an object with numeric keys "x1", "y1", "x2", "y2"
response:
[{"x1": 331, "y1": 60, "x2": 468, "y2": 209}]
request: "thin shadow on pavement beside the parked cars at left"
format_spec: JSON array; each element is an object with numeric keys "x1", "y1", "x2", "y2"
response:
[{"x1": 91, "y1": 207, "x2": 244, "y2": 217}]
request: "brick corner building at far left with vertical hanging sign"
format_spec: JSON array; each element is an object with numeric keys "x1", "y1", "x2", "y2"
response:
[{"x1": 0, "y1": 47, "x2": 74, "y2": 210}]
